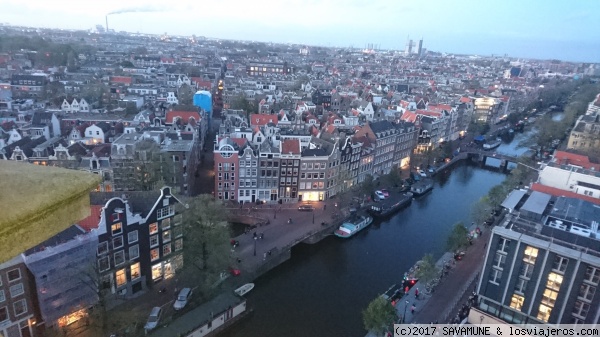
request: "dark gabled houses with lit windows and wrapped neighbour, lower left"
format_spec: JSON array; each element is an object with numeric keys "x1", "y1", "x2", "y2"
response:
[{"x1": 0, "y1": 187, "x2": 183, "y2": 336}]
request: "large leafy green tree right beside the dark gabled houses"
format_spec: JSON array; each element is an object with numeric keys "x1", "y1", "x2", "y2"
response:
[{"x1": 183, "y1": 194, "x2": 231, "y2": 292}]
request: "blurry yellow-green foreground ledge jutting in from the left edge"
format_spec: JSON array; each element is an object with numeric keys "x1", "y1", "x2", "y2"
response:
[{"x1": 0, "y1": 160, "x2": 100, "y2": 262}]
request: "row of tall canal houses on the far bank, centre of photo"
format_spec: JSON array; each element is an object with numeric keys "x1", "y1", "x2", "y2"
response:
[{"x1": 214, "y1": 114, "x2": 419, "y2": 203}]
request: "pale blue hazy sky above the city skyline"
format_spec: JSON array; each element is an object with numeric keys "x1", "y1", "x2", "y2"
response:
[{"x1": 0, "y1": 0, "x2": 600, "y2": 62}]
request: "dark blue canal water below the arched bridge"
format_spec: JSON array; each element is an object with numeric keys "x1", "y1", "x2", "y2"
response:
[{"x1": 222, "y1": 162, "x2": 505, "y2": 337}]
